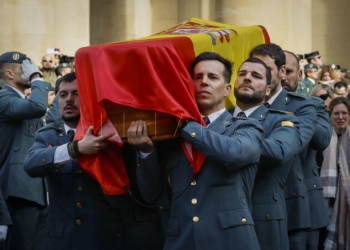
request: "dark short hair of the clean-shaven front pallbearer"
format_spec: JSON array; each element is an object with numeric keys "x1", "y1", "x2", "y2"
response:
[{"x1": 191, "y1": 52, "x2": 233, "y2": 83}]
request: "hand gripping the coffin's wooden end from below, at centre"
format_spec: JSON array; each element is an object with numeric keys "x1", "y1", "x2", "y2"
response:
[{"x1": 128, "y1": 121, "x2": 154, "y2": 153}]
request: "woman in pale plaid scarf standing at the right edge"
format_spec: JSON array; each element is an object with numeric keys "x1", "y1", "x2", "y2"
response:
[{"x1": 321, "y1": 97, "x2": 350, "y2": 250}]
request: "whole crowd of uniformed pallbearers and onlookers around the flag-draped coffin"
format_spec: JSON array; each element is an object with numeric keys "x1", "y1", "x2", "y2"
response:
[{"x1": 0, "y1": 43, "x2": 350, "y2": 250}]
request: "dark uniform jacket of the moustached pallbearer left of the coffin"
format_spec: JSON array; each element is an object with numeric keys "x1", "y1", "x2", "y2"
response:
[{"x1": 24, "y1": 122, "x2": 164, "y2": 250}]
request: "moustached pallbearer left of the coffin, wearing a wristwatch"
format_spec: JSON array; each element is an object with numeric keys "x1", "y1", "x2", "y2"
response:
[{"x1": 24, "y1": 73, "x2": 164, "y2": 250}]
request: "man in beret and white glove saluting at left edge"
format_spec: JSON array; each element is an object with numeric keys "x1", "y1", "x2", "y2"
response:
[{"x1": 0, "y1": 52, "x2": 50, "y2": 250}]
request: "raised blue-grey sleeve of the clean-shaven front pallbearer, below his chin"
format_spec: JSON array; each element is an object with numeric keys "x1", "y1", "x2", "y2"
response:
[{"x1": 181, "y1": 119, "x2": 264, "y2": 171}]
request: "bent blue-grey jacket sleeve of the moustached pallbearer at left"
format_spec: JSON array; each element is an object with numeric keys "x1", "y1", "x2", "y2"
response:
[{"x1": 24, "y1": 131, "x2": 57, "y2": 177}]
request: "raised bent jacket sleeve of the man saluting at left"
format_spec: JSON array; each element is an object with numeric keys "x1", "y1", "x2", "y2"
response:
[{"x1": 0, "y1": 81, "x2": 50, "y2": 121}]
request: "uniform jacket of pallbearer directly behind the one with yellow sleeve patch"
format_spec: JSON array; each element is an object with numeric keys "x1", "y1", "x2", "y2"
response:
[{"x1": 270, "y1": 89, "x2": 317, "y2": 230}]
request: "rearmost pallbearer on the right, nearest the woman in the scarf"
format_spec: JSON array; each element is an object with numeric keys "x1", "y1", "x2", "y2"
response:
[{"x1": 282, "y1": 51, "x2": 330, "y2": 250}]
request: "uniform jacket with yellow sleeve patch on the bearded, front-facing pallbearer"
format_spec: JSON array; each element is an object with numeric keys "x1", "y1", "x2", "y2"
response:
[{"x1": 249, "y1": 105, "x2": 300, "y2": 250}]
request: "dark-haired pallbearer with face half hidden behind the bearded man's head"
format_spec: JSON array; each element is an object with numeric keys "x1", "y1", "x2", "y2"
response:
[{"x1": 250, "y1": 43, "x2": 317, "y2": 249}]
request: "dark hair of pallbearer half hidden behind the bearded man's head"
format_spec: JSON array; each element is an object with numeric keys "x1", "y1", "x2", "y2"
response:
[{"x1": 249, "y1": 43, "x2": 286, "y2": 70}]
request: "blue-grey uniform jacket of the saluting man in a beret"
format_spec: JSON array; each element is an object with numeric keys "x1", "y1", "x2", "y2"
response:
[{"x1": 0, "y1": 81, "x2": 50, "y2": 206}]
